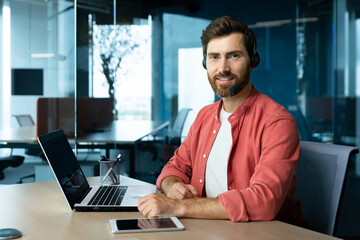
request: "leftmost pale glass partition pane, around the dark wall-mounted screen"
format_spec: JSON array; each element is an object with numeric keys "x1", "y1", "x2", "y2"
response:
[{"x1": 0, "y1": 0, "x2": 75, "y2": 132}]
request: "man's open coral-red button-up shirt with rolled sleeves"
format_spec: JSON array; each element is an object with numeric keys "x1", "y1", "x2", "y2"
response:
[{"x1": 157, "y1": 87, "x2": 302, "y2": 224}]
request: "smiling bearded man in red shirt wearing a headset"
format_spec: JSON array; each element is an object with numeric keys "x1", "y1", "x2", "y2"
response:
[{"x1": 138, "y1": 17, "x2": 301, "y2": 224}]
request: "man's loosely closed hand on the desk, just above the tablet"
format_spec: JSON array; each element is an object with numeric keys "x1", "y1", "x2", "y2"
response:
[{"x1": 138, "y1": 193, "x2": 180, "y2": 218}]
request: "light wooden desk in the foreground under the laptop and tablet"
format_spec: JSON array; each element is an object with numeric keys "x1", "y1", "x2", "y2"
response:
[{"x1": 0, "y1": 177, "x2": 336, "y2": 240}]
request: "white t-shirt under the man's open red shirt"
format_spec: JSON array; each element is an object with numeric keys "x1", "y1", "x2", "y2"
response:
[{"x1": 205, "y1": 107, "x2": 232, "y2": 198}]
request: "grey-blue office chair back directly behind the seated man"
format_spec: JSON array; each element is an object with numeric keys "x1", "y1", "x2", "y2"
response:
[{"x1": 295, "y1": 141, "x2": 359, "y2": 236}]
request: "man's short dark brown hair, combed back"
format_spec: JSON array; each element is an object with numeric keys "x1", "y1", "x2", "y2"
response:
[{"x1": 201, "y1": 16, "x2": 257, "y2": 59}]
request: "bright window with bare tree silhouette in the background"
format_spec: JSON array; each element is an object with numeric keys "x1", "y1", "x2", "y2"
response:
[{"x1": 90, "y1": 20, "x2": 151, "y2": 120}]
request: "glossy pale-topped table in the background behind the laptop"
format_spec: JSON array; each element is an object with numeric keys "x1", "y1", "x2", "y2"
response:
[{"x1": 0, "y1": 120, "x2": 169, "y2": 177}]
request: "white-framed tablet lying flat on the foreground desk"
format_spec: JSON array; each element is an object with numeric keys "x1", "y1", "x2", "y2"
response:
[{"x1": 109, "y1": 217, "x2": 185, "y2": 233}]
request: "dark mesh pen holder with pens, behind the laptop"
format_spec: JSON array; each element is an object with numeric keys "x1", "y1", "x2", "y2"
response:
[{"x1": 99, "y1": 160, "x2": 120, "y2": 185}]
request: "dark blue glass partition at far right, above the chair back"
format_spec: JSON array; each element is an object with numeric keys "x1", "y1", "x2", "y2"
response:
[{"x1": 296, "y1": 0, "x2": 360, "y2": 161}]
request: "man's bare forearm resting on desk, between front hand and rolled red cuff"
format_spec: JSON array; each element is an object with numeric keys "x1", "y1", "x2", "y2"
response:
[{"x1": 179, "y1": 198, "x2": 229, "y2": 219}]
